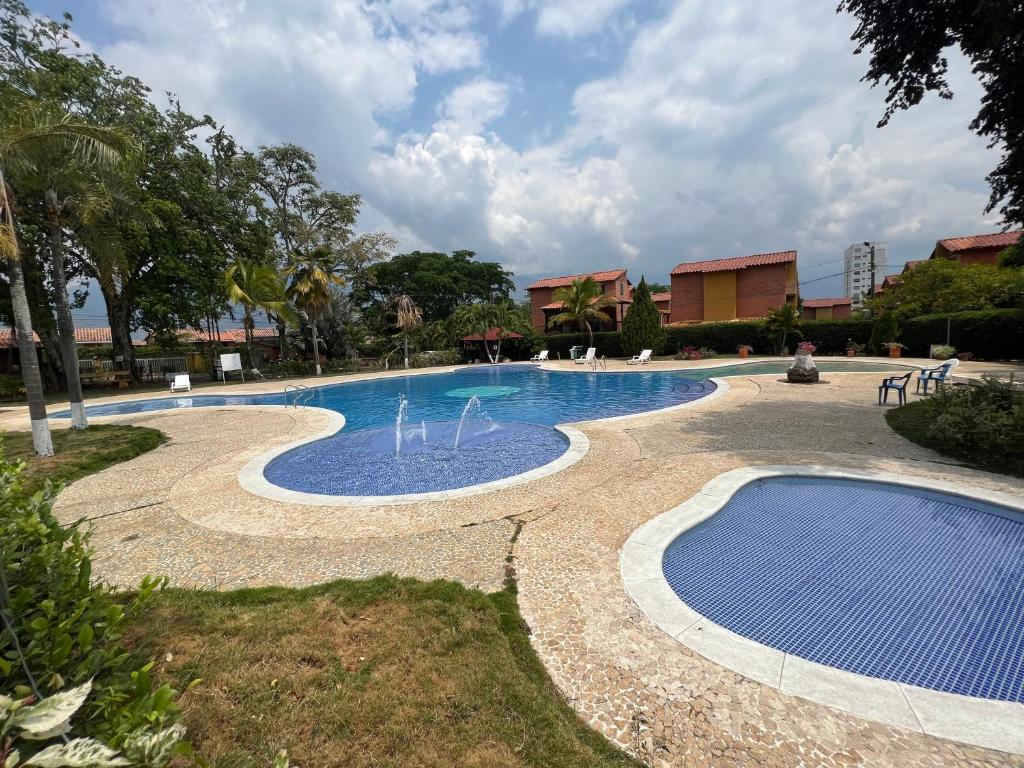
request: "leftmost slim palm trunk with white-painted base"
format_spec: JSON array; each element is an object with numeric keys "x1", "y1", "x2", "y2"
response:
[{"x1": 0, "y1": 174, "x2": 53, "y2": 456}]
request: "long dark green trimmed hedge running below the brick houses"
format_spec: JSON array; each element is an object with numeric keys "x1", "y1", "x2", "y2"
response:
[{"x1": 544, "y1": 309, "x2": 1024, "y2": 359}]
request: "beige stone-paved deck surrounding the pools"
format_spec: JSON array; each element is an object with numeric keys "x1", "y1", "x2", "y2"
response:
[{"x1": 0, "y1": 362, "x2": 1024, "y2": 766}]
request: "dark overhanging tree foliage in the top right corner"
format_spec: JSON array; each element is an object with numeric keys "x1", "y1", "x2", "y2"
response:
[{"x1": 838, "y1": 0, "x2": 1024, "y2": 231}]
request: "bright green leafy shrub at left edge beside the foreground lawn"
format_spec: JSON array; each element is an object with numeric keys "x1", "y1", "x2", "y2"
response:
[{"x1": 0, "y1": 459, "x2": 177, "y2": 746}]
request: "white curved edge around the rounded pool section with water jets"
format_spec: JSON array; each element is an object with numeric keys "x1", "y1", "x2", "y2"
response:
[{"x1": 238, "y1": 417, "x2": 590, "y2": 507}]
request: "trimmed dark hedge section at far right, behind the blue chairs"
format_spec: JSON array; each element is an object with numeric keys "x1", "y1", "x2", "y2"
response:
[{"x1": 901, "y1": 309, "x2": 1024, "y2": 359}]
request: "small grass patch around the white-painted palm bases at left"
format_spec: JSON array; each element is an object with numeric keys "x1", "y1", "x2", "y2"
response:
[{"x1": 3, "y1": 424, "x2": 167, "y2": 492}]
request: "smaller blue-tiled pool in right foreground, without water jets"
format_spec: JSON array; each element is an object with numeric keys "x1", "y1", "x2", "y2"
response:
[{"x1": 663, "y1": 477, "x2": 1024, "y2": 701}]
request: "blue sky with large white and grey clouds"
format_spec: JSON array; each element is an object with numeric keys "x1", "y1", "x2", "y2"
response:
[{"x1": 39, "y1": 0, "x2": 999, "y2": 305}]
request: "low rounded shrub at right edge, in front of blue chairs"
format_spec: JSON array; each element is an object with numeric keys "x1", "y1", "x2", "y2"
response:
[{"x1": 924, "y1": 378, "x2": 1024, "y2": 475}]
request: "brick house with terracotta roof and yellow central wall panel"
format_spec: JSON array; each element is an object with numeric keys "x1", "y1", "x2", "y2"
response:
[{"x1": 670, "y1": 251, "x2": 799, "y2": 323}]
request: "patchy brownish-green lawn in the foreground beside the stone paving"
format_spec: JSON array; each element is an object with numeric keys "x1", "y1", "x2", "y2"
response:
[{"x1": 126, "y1": 577, "x2": 640, "y2": 768}]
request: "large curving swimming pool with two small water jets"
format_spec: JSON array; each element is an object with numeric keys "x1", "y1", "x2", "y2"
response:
[{"x1": 57, "y1": 361, "x2": 913, "y2": 503}]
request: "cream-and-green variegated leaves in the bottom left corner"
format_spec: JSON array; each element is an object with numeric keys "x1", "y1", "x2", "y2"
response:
[{"x1": 0, "y1": 681, "x2": 184, "y2": 768}]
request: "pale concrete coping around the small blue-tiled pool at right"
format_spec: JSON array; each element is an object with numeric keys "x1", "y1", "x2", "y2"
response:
[{"x1": 620, "y1": 465, "x2": 1024, "y2": 754}]
